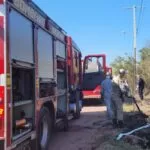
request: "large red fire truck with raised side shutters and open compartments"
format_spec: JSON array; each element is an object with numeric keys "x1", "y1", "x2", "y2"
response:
[{"x1": 0, "y1": 0, "x2": 81, "y2": 150}]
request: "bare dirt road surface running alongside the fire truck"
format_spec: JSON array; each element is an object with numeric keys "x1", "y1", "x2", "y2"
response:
[{"x1": 50, "y1": 106, "x2": 108, "y2": 150}]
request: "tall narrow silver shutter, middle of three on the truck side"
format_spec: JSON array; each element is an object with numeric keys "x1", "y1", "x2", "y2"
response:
[{"x1": 38, "y1": 29, "x2": 54, "y2": 79}]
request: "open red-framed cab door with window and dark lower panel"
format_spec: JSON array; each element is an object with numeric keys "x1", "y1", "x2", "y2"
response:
[{"x1": 82, "y1": 54, "x2": 107, "y2": 100}]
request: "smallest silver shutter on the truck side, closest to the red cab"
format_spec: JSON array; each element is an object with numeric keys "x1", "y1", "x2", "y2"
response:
[{"x1": 56, "y1": 41, "x2": 66, "y2": 59}]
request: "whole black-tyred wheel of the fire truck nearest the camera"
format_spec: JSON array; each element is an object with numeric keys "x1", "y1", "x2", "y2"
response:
[{"x1": 38, "y1": 107, "x2": 52, "y2": 150}]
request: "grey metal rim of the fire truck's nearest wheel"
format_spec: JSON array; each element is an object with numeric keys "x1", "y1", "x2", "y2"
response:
[{"x1": 40, "y1": 116, "x2": 48, "y2": 148}]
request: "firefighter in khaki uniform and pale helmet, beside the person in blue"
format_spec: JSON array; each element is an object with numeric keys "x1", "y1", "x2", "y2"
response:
[{"x1": 112, "y1": 69, "x2": 130, "y2": 128}]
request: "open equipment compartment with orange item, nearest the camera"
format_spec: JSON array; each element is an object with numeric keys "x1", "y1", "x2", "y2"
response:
[{"x1": 12, "y1": 66, "x2": 34, "y2": 140}]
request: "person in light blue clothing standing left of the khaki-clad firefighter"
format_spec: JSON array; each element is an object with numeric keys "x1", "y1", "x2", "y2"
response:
[{"x1": 101, "y1": 73, "x2": 113, "y2": 120}]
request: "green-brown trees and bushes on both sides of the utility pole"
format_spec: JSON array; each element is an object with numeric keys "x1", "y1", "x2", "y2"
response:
[{"x1": 111, "y1": 47, "x2": 150, "y2": 94}]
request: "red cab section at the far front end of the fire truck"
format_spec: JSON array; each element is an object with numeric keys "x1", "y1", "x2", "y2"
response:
[{"x1": 67, "y1": 37, "x2": 82, "y2": 118}]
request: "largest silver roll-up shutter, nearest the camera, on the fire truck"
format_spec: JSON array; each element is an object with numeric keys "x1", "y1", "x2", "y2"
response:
[{"x1": 9, "y1": 9, "x2": 33, "y2": 63}]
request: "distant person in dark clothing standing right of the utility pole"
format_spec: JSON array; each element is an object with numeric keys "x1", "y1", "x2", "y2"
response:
[{"x1": 137, "y1": 75, "x2": 145, "y2": 100}]
